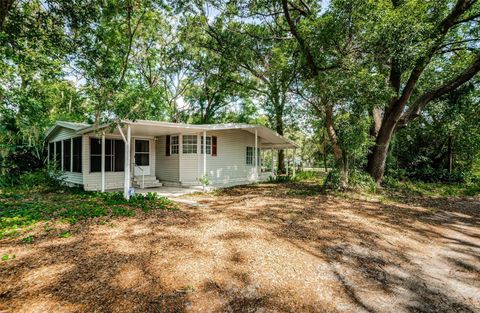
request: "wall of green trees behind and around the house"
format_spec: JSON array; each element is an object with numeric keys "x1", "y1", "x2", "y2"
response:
[{"x1": 0, "y1": 0, "x2": 480, "y2": 184}]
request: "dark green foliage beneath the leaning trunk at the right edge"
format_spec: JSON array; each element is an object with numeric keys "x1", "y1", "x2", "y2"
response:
[{"x1": 387, "y1": 83, "x2": 480, "y2": 183}]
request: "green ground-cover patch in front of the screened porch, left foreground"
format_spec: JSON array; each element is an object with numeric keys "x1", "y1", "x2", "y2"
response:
[{"x1": 0, "y1": 187, "x2": 177, "y2": 239}]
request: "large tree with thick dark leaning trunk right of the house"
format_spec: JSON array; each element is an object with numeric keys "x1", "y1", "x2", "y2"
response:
[{"x1": 281, "y1": 0, "x2": 480, "y2": 182}]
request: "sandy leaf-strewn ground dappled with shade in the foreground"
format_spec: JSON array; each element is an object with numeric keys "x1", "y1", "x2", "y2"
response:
[{"x1": 0, "y1": 184, "x2": 480, "y2": 312}]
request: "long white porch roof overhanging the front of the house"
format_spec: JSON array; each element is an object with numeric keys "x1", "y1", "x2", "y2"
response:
[{"x1": 77, "y1": 120, "x2": 298, "y2": 148}]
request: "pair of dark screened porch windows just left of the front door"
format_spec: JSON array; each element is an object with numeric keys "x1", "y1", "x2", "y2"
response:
[{"x1": 90, "y1": 138, "x2": 125, "y2": 172}]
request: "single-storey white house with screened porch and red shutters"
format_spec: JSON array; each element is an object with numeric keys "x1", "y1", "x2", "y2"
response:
[{"x1": 46, "y1": 120, "x2": 297, "y2": 195}]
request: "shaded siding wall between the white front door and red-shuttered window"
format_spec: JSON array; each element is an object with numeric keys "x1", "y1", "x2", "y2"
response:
[{"x1": 155, "y1": 136, "x2": 180, "y2": 182}]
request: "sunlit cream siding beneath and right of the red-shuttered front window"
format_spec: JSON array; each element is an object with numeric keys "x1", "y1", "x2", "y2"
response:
[{"x1": 180, "y1": 130, "x2": 261, "y2": 186}]
